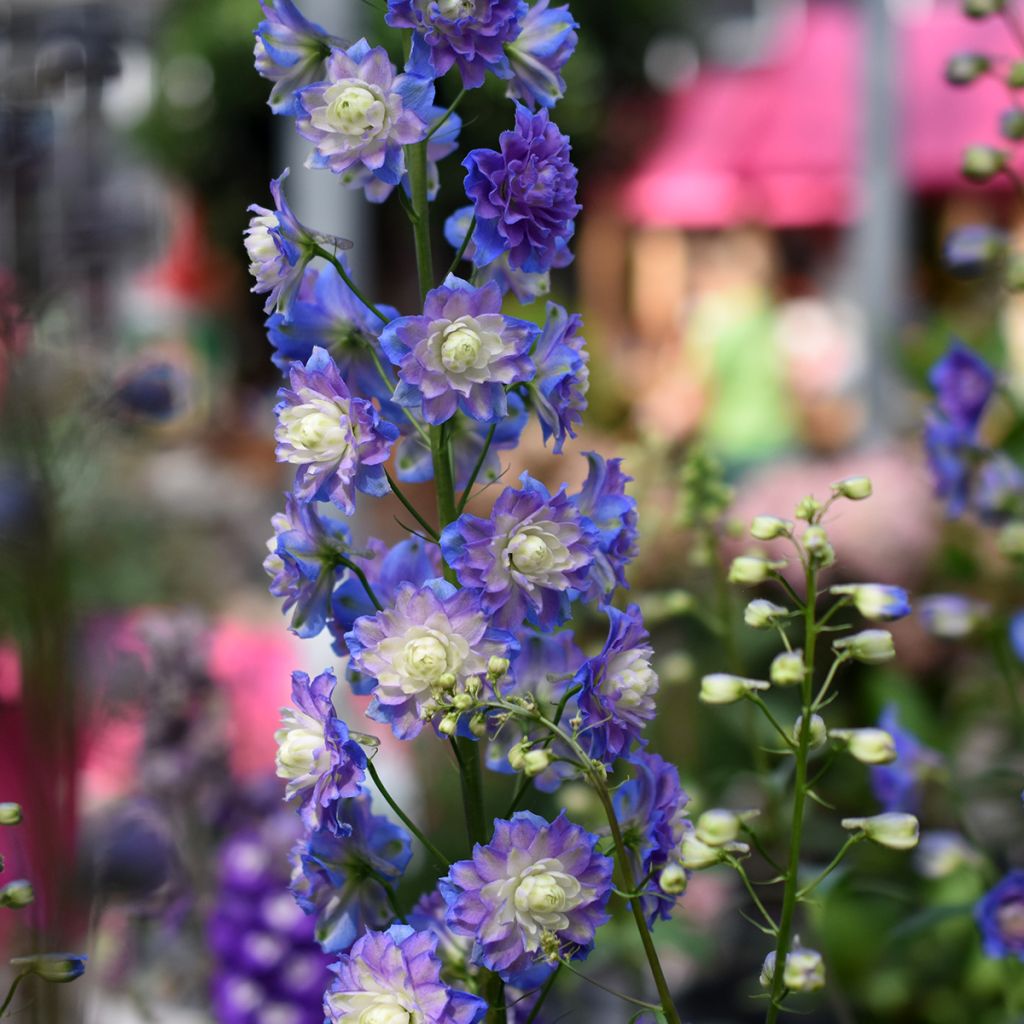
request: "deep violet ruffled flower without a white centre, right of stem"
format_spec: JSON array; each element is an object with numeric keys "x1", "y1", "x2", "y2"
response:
[{"x1": 462, "y1": 105, "x2": 580, "y2": 273}]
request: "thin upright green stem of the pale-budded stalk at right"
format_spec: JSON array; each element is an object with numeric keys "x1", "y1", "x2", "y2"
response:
[{"x1": 765, "y1": 564, "x2": 818, "y2": 1024}]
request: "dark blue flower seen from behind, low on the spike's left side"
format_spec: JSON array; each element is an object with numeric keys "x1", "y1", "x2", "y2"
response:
[{"x1": 291, "y1": 793, "x2": 412, "y2": 953}]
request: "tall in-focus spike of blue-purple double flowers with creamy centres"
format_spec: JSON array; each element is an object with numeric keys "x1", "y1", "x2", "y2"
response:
[{"x1": 246, "y1": 0, "x2": 687, "y2": 1024}]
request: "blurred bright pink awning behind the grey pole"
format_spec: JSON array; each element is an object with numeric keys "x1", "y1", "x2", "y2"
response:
[{"x1": 622, "y1": 2, "x2": 1008, "y2": 228}]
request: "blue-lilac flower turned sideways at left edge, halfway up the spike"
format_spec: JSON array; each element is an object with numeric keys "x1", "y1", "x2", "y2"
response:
[{"x1": 263, "y1": 494, "x2": 351, "y2": 638}]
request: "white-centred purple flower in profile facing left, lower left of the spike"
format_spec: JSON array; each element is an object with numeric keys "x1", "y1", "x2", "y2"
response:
[{"x1": 273, "y1": 669, "x2": 367, "y2": 835}]
